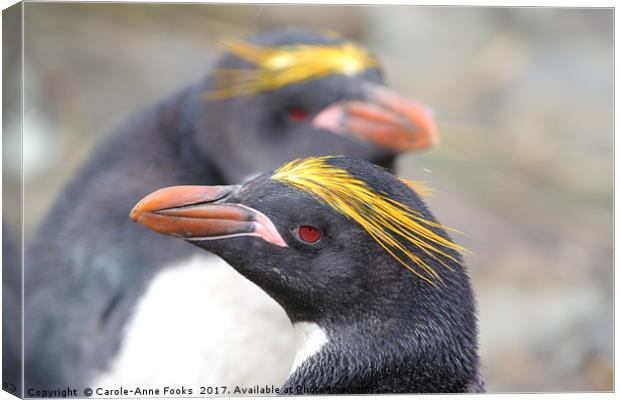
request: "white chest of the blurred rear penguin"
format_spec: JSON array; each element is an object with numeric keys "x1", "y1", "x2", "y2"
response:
[{"x1": 94, "y1": 254, "x2": 295, "y2": 387}]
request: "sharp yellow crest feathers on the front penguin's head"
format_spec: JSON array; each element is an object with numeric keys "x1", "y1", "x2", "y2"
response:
[{"x1": 271, "y1": 156, "x2": 466, "y2": 285}]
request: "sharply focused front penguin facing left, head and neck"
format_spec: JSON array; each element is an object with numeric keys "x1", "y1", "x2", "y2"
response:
[{"x1": 131, "y1": 157, "x2": 483, "y2": 394}]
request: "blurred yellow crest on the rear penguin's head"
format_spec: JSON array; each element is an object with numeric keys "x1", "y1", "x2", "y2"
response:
[{"x1": 206, "y1": 40, "x2": 379, "y2": 100}]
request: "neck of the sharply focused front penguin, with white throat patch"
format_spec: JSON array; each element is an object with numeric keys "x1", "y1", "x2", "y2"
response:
[{"x1": 282, "y1": 296, "x2": 479, "y2": 394}]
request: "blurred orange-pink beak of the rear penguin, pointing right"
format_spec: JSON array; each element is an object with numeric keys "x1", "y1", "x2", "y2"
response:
[{"x1": 312, "y1": 84, "x2": 439, "y2": 153}]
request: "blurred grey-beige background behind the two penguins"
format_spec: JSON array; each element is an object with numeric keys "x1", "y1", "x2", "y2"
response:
[{"x1": 4, "y1": 3, "x2": 613, "y2": 392}]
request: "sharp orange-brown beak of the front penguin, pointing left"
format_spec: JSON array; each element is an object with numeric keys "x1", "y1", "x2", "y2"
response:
[{"x1": 129, "y1": 185, "x2": 288, "y2": 247}]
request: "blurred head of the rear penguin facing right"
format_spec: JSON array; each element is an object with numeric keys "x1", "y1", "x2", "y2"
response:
[{"x1": 193, "y1": 28, "x2": 437, "y2": 182}]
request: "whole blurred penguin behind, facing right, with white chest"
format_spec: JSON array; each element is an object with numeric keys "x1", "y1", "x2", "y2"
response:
[{"x1": 24, "y1": 29, "x2": 435, "y2": 389}]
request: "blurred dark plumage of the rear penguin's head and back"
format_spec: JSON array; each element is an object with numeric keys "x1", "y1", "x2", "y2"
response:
[{"x1": 24, "y1": 29, "x2": 434, "y2": 389}]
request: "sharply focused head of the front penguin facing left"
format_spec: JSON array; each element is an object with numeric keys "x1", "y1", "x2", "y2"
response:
[{"x1": 131, "y1": 156, "x2": 469, "y2": 322}]
